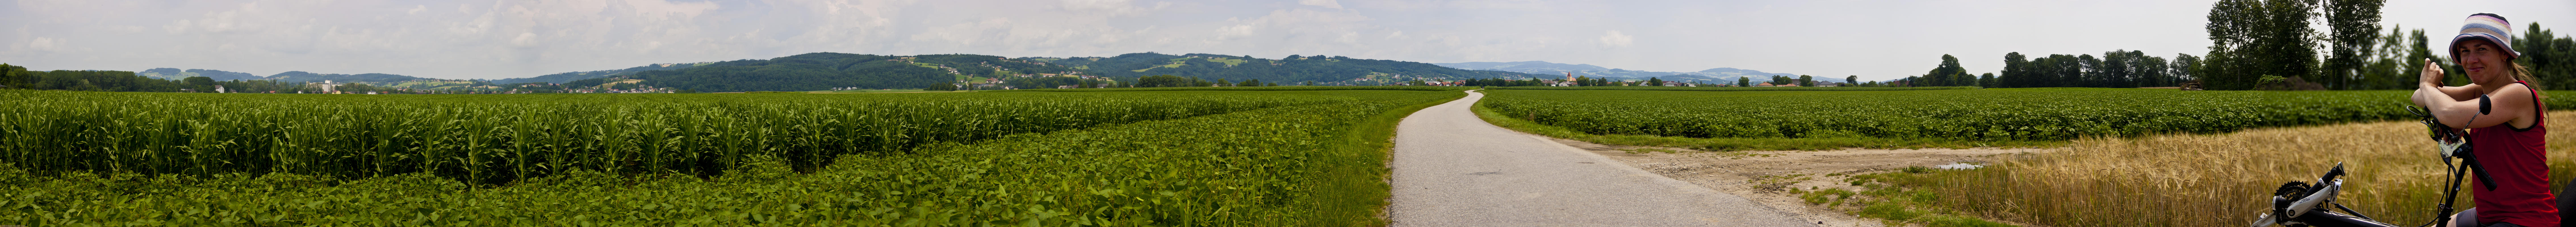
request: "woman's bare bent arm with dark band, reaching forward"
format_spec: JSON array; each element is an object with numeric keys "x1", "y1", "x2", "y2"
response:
[{"x1": 2416, "y1": 83, "x2": 2537, "y2": 129}]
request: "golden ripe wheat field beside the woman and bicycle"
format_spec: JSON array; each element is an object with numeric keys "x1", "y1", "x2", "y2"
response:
[{"x1": 1932, "y1": 111, "x2": 2576, "y2": 227}]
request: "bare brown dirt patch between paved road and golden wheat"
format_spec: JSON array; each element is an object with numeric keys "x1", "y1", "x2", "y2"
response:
[{"x1": 1556, "y1": 139, "x2": 2048, "y2": 227}]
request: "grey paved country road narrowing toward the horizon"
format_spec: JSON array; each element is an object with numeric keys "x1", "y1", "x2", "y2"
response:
[{"x1": 1388, "y1": 93, "x2": 1813, "y2": 227}]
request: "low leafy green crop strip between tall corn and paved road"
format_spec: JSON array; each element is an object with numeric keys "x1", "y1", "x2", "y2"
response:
[{"x1": 0, "y1": 90, "x2": 1463, "y2": 227}]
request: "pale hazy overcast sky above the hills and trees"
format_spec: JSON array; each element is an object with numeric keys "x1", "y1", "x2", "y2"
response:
[{"x1": 0, "y1": 0, "x2": 2576, "y2": 80}]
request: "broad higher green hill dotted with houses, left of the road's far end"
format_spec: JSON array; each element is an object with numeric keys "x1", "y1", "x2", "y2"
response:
[{"x1": 618, "y1": 52, "x2": 1533, "y2": 93}]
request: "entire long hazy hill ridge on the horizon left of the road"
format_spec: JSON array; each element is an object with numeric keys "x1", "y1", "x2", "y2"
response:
[{"x1": 139, "y1": 52, "x2": 1566, "y2": 93}]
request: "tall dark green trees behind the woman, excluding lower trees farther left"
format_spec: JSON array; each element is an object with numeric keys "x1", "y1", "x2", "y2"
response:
[{"x1": 2192, "y1": 0, "x2": 2576, "y2": 90}]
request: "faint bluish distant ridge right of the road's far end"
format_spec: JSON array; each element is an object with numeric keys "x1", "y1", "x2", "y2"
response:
[{"x1": 1435, "y1": 62, "x2": 1798, "y2": 80}]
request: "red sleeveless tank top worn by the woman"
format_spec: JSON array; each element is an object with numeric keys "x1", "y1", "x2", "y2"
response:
[{"x1": 2468, "y1": 80, "x2": 2558, "y2": 227}]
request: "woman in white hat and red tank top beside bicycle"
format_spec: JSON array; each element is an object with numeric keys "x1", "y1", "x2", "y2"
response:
[{"x1": 2414, "y1": 13, "x2": 2558, "y2": 227}]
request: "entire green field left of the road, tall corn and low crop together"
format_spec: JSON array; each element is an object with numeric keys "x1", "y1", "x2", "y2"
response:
[{"x1": 0, "y1": 90, "x2": 1463, "y2": 227}]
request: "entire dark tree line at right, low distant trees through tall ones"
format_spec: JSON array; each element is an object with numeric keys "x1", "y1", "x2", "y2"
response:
[{"x1": 1901, "y1": 0, "x2": 2576, "y2": 90}]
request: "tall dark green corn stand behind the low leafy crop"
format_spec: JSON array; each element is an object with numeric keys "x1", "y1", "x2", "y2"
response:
[{"x1": 0, "y1": 90, "x2": 1334, "y2": 183}]
